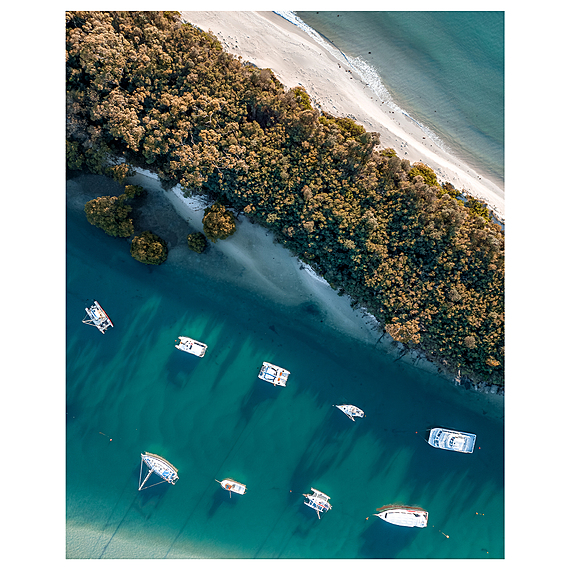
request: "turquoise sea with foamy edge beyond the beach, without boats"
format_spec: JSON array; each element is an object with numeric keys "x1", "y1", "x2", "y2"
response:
[{"x1": 283, "y1": 11, "x2": 504, "y2": 186}]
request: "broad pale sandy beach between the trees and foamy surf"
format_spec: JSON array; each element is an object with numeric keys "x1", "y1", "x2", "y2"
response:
[{"x1": 181, "y1": 11, "x2": 505, "y2": 220}]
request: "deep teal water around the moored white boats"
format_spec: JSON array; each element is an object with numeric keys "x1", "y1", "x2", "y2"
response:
[{"x1": 66, "y1": 177, "x2": 504, "y2": 558}]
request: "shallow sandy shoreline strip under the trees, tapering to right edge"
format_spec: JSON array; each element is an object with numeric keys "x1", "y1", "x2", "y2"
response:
[{"x1": 129, "y1": 167, "x2": 504, "y2": 408}]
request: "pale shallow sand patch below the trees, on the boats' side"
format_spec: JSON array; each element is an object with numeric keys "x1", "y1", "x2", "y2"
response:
[{"x1": 130, "y1": 164, "x2": 391, "y2": 349}]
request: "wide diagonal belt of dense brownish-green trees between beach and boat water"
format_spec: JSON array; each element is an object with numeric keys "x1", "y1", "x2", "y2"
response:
[{"x1": 66, "y1": 12, "x2": 504, "y2": 383}]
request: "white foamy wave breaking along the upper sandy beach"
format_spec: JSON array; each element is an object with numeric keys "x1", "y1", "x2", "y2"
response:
[{"x1": 273, "y1": 10, "x2": 450, "y2": 152}]
